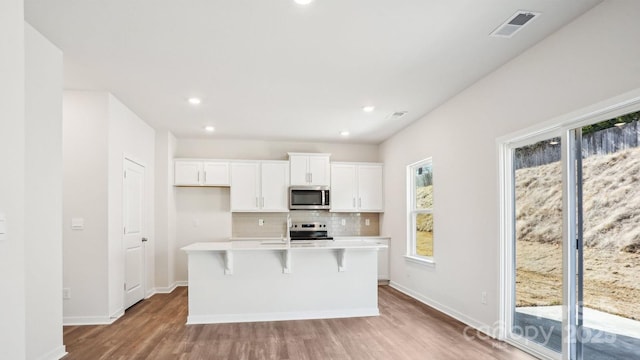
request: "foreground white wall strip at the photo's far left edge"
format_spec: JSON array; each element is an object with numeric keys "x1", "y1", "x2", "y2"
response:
[{"x1": 0, "y1": 0, "x2": 26, "y2": 359}]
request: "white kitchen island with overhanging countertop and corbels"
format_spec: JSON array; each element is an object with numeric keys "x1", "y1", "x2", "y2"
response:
[{"x1": 182, "y1": 239, "x2": 386, "y2": 324}]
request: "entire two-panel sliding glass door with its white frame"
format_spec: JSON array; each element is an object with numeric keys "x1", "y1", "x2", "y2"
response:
[{"x1": 503, "y1": 112, "x2": 640, "y2": 360}]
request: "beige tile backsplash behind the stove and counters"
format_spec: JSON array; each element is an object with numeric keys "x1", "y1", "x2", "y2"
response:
[{"x1": 231, "y1": 210, "x2": 380, "y2": 237}]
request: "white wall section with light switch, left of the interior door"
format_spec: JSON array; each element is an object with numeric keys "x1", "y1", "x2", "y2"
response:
[{"x1": 62, "y1": 91, "x2": 109, "y2": 323}]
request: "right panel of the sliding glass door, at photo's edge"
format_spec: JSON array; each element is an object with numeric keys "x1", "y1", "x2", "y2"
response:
[{"x1": 576, "y1": 113, "x2": 640, "y2": 360}]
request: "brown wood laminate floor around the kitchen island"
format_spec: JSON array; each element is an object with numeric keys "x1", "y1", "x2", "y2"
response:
[{"x1": 64, "y1": 286, "x2": 533, "y2": 360}]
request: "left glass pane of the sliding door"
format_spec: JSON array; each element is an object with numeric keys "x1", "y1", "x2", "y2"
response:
[{"x1": 510, "y1": 136, "x2": 562, "y2": 353}]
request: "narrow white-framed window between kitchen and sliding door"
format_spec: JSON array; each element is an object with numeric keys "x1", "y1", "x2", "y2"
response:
[{"x1": 407, "y1": 158, "x2": 433, "y2": 262}]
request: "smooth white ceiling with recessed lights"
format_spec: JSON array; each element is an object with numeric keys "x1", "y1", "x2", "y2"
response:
[{"x1": 25, "y1": 0, "x2": 600, "y2": 144}]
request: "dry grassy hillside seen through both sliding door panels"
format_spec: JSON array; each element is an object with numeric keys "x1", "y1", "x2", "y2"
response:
[{"x1": 516, "y1": 148, "x2": 640, "y2": 319}]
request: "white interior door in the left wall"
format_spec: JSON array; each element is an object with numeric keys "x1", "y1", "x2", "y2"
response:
[{"x1": 123, "y1": 159, "x2": 146, "y2": 308}]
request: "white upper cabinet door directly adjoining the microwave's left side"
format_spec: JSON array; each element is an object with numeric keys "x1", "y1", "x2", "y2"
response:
[{"x1": 260, "y1": 161, "x2": 289, "y2": 212}]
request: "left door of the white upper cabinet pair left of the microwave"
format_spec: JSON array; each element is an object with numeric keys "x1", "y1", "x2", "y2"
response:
[{"x1": 231, "y1": 162, "x2": 260, "y2": 211}]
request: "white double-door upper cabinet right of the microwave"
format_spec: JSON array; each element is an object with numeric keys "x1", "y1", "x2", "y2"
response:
[{"x1": 331, "y1": 162, "x2": 384, "y2": 212}]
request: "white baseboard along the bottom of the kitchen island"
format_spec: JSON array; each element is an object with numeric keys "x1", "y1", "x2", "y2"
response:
[{"x1": 187, "y1": 308, "x2": 380, "y2": 325}]
